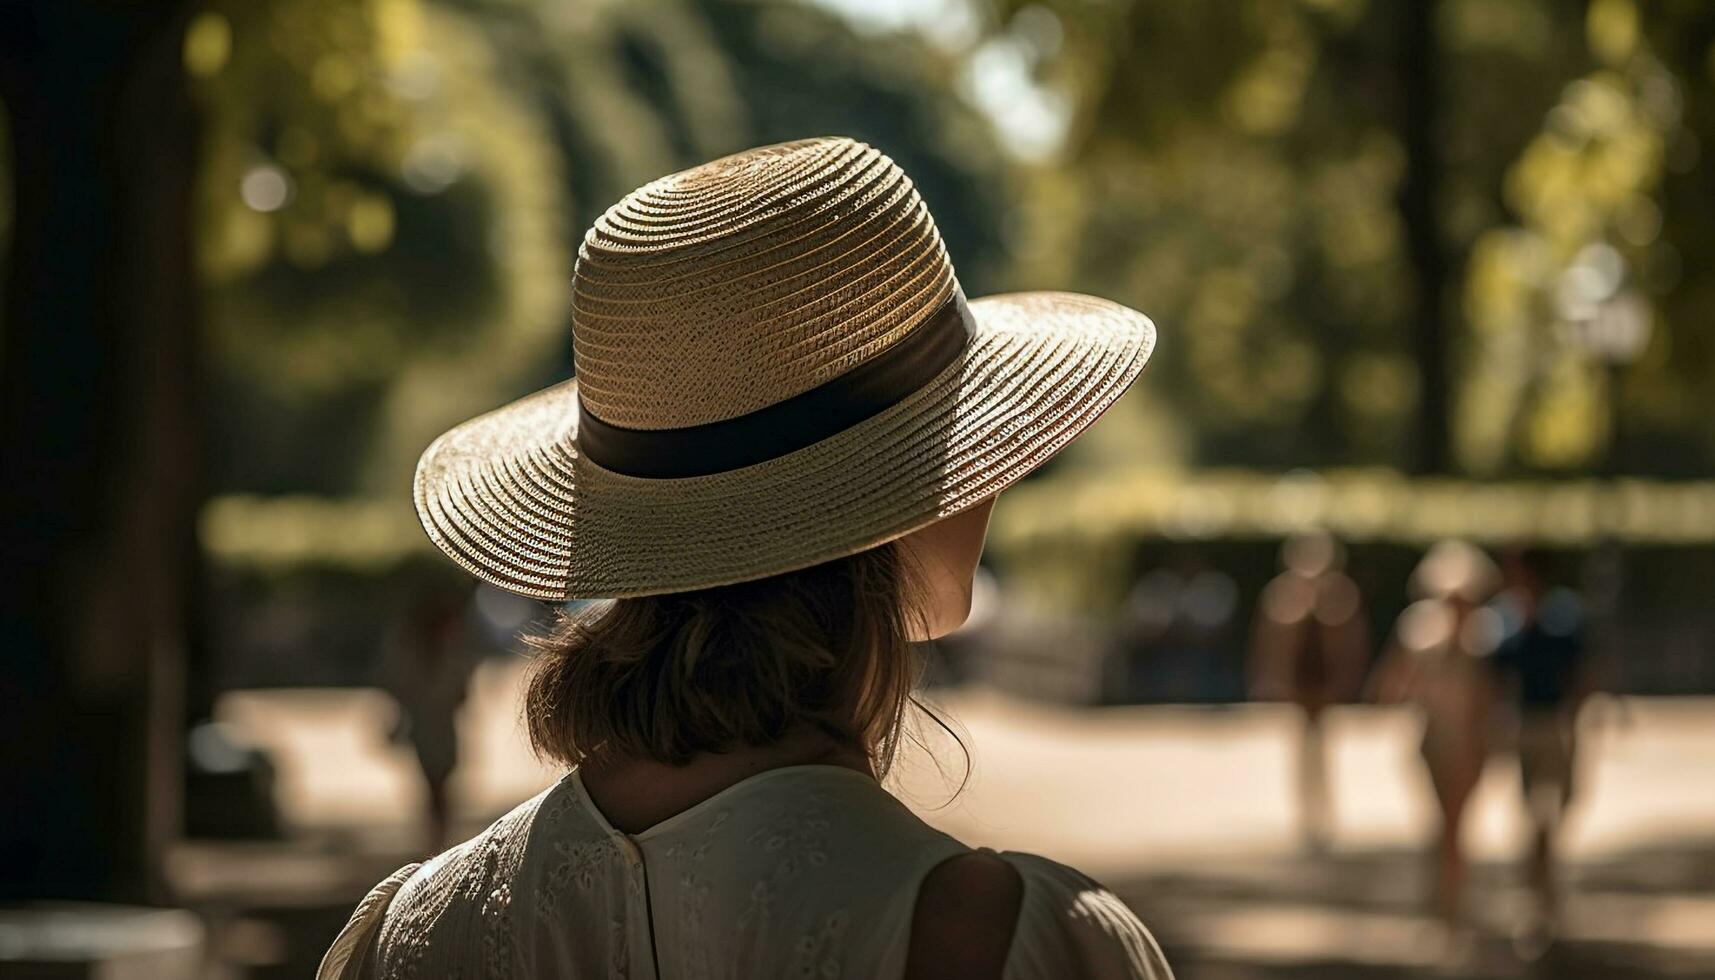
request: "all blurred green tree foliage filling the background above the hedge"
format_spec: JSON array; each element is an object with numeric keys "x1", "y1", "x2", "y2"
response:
[{"x1": 184, "y1": 0, "x2": 1715, "y2": 559}]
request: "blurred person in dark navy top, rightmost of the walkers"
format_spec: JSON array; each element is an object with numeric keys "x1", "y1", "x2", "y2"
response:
[{"x1": 1492, "y1": 547, "x2": 1595, "y2": 939}]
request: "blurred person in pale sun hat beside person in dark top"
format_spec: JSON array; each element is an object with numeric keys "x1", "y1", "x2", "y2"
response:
[{"x1": 1372, "y1": 541, "x2": 1499, "y2": 935}]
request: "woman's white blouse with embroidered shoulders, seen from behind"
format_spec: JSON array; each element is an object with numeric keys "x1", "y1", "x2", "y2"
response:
[{"x1": 317, "y1": 765, "x2": 1171, "y2": 980}]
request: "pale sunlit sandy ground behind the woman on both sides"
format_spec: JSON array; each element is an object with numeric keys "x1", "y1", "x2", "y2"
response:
[{"x1": 177, "y1": 661, "x2": 1715, "y2": 977}]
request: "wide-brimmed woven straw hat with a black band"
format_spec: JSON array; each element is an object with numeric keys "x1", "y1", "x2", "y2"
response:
[{"x1": 415, "y1": 137, "x2": 1156, "y2": 599}]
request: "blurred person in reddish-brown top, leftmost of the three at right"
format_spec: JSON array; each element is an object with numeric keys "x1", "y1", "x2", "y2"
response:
[{"x1": 1250, "y1": 530, "x2": 1370, "y2": 851}]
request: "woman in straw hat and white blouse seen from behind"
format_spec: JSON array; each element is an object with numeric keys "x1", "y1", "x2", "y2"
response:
[{"x1": 321, "y1": 139, "x2": 1170, "y2": 980}]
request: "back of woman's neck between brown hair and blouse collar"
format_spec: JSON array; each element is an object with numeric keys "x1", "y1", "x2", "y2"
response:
[{"x1": 578, "y1": 728, "x2": 875, "y2": 834}]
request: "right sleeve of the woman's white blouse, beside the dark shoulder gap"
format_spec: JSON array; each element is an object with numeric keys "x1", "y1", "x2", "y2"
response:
[{"x1": 1002, "y1": 851, "x2": 1173, "y2": 980}]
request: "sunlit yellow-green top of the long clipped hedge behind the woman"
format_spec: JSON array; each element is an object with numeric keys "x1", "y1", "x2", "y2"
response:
[{"x1": 201, "y1": 470, "x2": 1715, "y2": 570}]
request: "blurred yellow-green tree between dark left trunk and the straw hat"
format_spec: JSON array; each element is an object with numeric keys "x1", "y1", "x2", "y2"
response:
[{"x1": 187, "y1": 0, "x2": 569, "y2": 494}]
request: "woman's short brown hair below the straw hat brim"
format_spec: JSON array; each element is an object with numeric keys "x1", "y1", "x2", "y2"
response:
[{"x1": 525, "y1": 542, "x2": 923, "y2": 772}]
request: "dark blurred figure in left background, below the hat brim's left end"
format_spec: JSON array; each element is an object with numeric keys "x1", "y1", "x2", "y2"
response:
[{"x1": 382, "y1": 575, "x2": 475, "y2": 851}]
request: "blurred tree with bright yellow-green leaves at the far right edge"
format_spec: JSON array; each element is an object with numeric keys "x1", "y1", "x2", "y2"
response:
[{"x1": 1459, "y1": 0, "x2": 1715, "y2": 475}]
